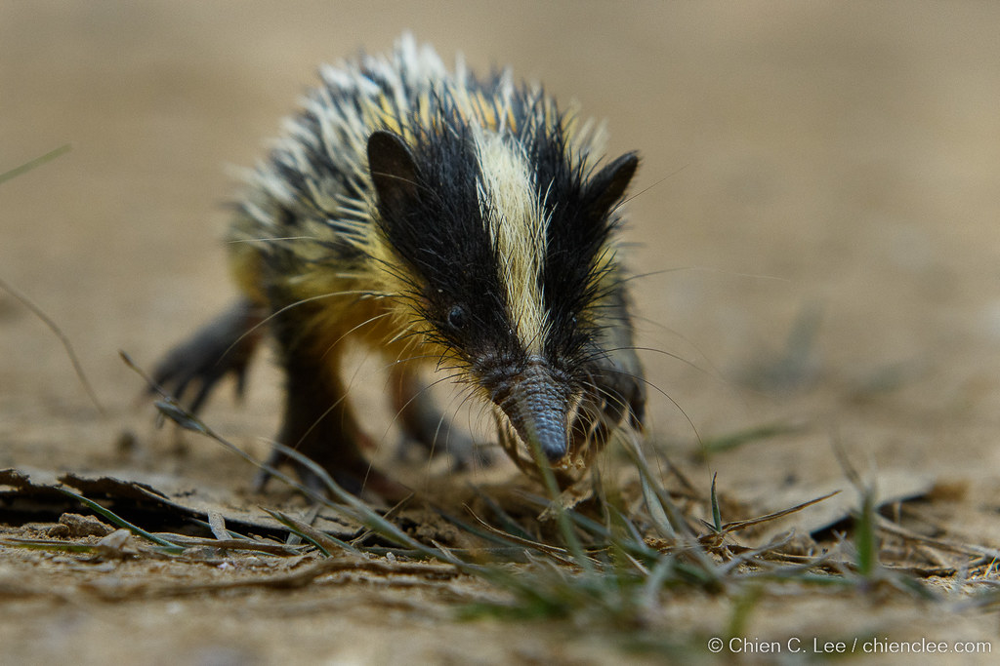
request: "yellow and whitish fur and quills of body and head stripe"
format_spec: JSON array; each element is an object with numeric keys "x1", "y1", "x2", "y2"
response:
[{"x1": 229, "y1": 36, "x2": 610, "y2": 384}]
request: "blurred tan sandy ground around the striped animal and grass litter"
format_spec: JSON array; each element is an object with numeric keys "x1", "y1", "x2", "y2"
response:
[{"x1": 0, "y1": 0, "x2": 1000, "y2": 664}]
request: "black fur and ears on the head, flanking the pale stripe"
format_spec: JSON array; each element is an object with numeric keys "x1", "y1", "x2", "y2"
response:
[{"x1": 368, "y1": 88, "x2": 638, "y2": 400}]
